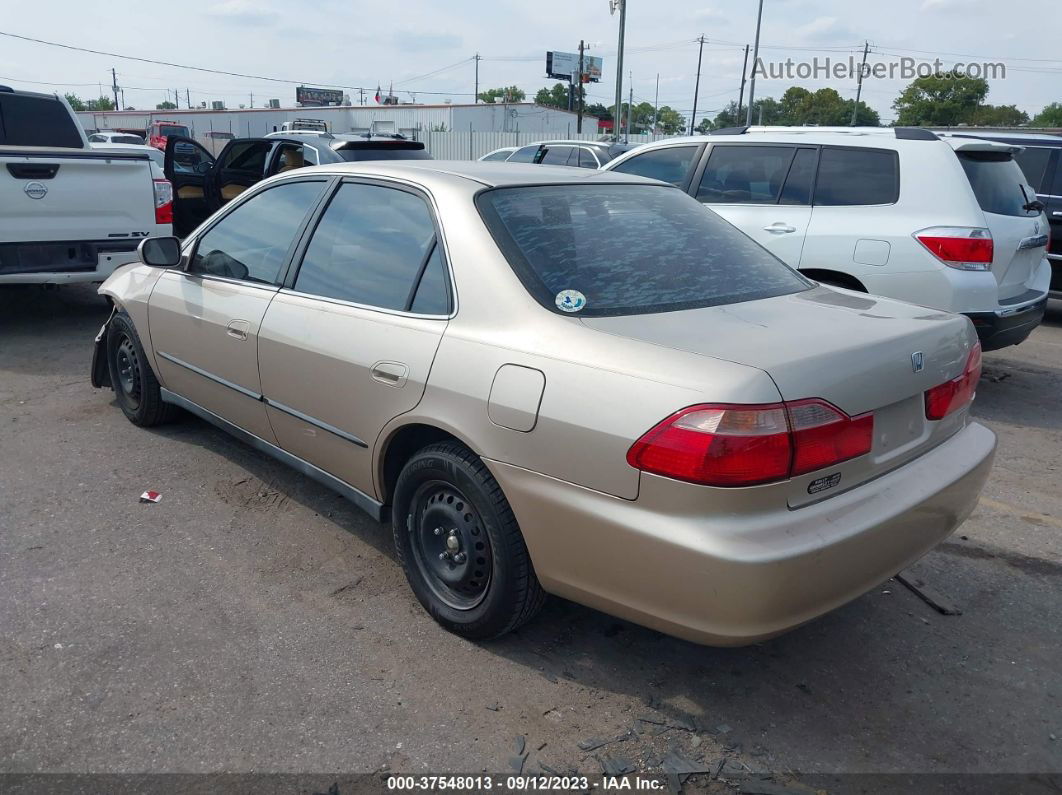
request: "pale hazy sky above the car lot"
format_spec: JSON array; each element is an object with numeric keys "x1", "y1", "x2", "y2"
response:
[{"x1": 0, "y1": 0, "x2": 1062, "y2": 122}]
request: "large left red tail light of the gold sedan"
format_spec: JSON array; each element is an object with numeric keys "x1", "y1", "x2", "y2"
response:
[{"x1": 627, "y1": 399, "x2": 874, "y2": 486}]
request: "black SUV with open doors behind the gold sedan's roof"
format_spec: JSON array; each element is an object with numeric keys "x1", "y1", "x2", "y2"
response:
[{"x1": 162, "y1": 131, "x2": 431, "y2": 238}]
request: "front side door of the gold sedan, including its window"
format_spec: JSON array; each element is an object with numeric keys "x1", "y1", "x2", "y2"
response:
[{"x1": 148, "y1": 177, "x2": 327, "y2": 442}]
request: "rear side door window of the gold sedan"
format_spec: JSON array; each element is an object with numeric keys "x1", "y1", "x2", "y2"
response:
[{"x1": 294, "y1": 183, "x2": 448, "y2": 314}]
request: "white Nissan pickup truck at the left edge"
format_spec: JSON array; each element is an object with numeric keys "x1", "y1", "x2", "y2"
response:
[{"x1": 0, "y1": 86, "x2": 173, "y2": 284}]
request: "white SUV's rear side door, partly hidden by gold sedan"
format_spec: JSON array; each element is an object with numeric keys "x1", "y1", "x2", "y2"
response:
[{"x1": 690, "y1": 143, "x2": 818, "y2": 267}]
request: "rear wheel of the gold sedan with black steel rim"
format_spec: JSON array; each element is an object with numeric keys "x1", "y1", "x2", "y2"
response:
[{"x1": 391, "y1": 442, "x2": 546, "y2": 640}]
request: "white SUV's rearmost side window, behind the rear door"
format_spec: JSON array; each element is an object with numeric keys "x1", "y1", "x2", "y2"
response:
[{"x1": 815, "y1": 146, "x2": 900, "y2": 207}]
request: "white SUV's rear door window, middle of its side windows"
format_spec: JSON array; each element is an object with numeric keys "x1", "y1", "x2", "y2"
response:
[{"x1": 697, "y1": 143, "x2": 797, "y2": 204}]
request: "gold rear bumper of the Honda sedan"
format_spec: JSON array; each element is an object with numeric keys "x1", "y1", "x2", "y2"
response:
[{"x1": 486, "y1": 424, "x2": 996, "y2": 645}]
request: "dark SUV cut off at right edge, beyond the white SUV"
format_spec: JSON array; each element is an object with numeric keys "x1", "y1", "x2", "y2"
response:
[{"x1": 953, "y1": 129, "x2": 1062, "y2": 298}]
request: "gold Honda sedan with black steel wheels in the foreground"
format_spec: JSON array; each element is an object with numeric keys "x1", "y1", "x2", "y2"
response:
[{"x1": 92, "y1": 161, "x2": 995, "y2": 645}]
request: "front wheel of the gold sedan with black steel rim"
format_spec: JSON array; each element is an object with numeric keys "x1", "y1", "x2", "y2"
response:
[{"x1": 107, "y1": 312, "x2": 177, "y2": 428}]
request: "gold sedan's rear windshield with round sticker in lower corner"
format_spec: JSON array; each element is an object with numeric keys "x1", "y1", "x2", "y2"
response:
[{"x1": 477, "y1": 185, "x2": 811, "y2": 317}]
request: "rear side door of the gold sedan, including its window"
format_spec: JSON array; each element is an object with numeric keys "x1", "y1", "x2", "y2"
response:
[{"x1": 258, "y1": 180, "x2": 451, "y2": 495}]
